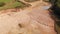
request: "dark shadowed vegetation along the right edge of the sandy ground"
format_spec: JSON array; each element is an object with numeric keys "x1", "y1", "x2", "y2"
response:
[{"x1": 49, "y1": 0, "x2": 60, "y2": 34}]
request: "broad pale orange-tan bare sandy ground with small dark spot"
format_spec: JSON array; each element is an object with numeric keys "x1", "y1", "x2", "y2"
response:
[{"x1": 0, "y1": 1, "x2": 56, "y2": 34}]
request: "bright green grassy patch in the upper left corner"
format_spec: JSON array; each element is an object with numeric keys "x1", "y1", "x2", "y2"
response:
[{"x1": 0, "y1": 0, "x2": 29, "y2": 10}]
